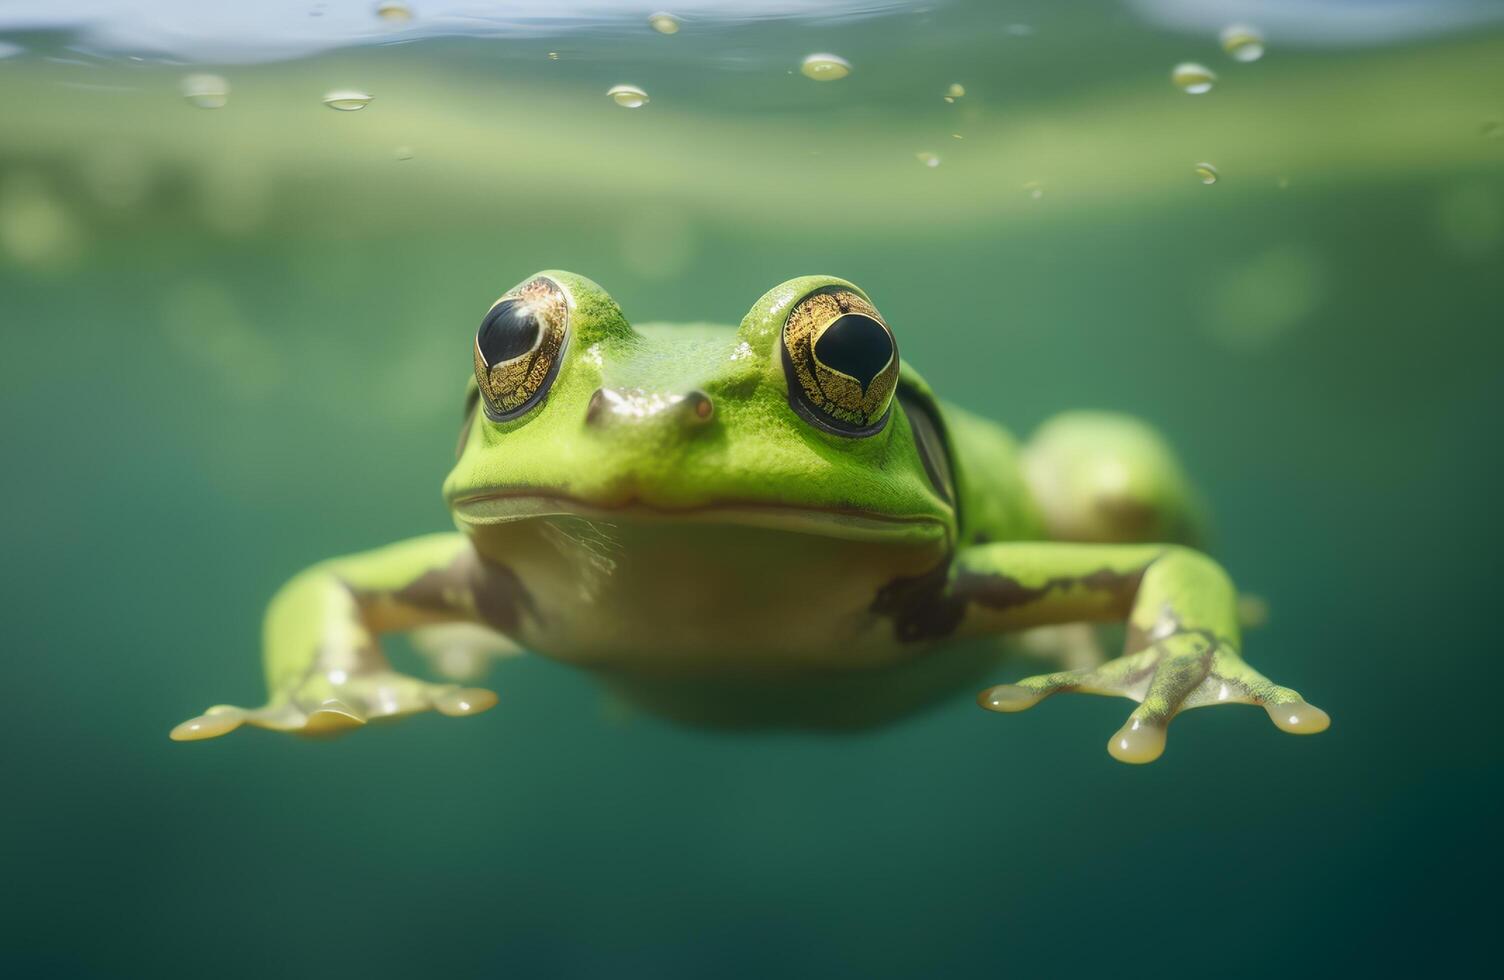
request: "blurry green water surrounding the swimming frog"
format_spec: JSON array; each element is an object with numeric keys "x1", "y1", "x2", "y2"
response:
[{"x1": 0, "y1": 2, "x2": 1504, "y2": 977}]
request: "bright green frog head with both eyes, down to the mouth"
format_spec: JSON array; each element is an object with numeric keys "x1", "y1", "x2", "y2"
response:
[{"x1": 444, "y1": 272, "x2": 955, "y2": 546}]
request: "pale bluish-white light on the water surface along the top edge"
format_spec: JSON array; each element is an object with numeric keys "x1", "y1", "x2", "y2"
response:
[{"x1": 0, "y1": 0, "x2": 1504, "y2": 63}]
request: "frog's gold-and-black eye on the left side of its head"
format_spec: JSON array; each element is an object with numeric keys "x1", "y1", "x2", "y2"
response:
[{"x1": 475, "y1": 277, "x2": 569, "y2": 422}]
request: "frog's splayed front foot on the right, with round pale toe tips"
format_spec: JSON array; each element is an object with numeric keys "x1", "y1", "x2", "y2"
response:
[{"x1": 978, "y1": 631, "x2": 1331, "y2": 762}]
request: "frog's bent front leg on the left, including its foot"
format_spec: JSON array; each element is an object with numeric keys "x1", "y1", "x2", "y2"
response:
[{"x1": 171, "y1": 534, "x2": 528, "y2": 741}]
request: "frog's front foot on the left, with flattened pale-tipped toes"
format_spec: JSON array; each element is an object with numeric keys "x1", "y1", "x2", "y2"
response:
[{"x1": 171, "y1": 661, "x2": 496, "y2": 741}]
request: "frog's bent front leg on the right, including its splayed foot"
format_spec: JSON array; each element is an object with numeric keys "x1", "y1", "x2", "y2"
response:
[{"x1": 945, "y1": 543, "x2": 1330, "y2": 762}]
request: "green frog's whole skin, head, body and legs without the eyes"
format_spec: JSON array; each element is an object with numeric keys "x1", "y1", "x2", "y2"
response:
[{"x1": 173, "y1": 272, "x2": 1327, "y2": 762}]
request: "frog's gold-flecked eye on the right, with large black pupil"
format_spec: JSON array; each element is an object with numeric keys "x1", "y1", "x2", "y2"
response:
[{"x1": 784, "y1": 287, "x2": 898, "y2": 436}]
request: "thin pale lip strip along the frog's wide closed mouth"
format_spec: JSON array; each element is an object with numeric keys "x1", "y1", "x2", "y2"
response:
[{"x1": 450, "y1": 490, "x2": 949, "y2": 541}]
